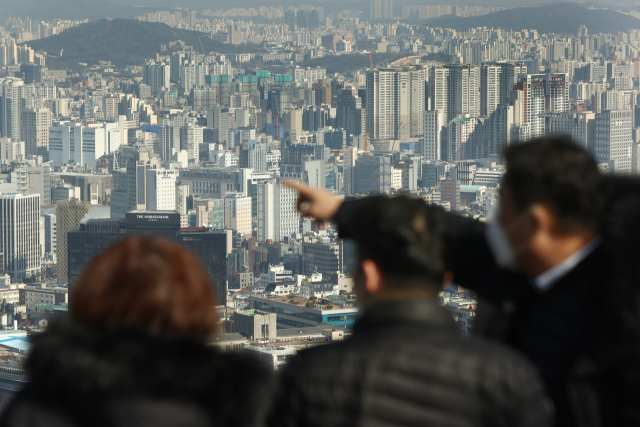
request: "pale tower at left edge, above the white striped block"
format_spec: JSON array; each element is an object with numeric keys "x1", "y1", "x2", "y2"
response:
[{"x1": 0, "y1": 77, "x2": 31, "y2": 141}]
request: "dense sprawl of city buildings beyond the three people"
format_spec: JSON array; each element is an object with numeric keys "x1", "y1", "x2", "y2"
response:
[{"x1": 0, "y1": 0, "x2": 640, "y2": 392}]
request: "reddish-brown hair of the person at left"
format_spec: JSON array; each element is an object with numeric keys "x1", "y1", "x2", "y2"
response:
[{"x1": 70, "y1": 236, "x2": 218, "y2": 336}]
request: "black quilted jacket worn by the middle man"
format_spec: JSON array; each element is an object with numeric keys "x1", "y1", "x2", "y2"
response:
[{"x1": 269, "y1": 301, "x2": 553, "y2": 427}]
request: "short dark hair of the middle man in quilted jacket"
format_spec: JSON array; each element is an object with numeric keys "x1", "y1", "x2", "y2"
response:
[{"x1": 350, "y1": 195, "x2": 446, "y2": 289}]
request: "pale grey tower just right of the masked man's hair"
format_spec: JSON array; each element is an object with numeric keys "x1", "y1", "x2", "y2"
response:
[{"x1": 592, "y1": 110, "x2": 633, "y2": 175}]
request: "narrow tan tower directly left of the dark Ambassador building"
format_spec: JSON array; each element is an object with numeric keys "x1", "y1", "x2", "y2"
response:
[{"x1": 56, "y1": 200, "x2": 91, "y2": 283}]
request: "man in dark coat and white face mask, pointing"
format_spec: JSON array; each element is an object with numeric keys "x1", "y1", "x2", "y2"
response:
[{"x1": 284, "y1": 138, "x2": 640, "y2": 427}]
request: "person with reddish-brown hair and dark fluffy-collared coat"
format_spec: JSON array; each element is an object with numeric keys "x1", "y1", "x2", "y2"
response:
[{"x1": 0, "y1": 237, "x2": 270, "y2": 427}]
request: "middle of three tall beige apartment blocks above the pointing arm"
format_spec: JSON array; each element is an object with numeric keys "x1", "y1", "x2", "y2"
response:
[{"x1": 429, "y1": 64, "x2": 480, "y2": 123}]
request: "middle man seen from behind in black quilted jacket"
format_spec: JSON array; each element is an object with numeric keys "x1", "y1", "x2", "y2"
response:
[{"x1": 269, "y1": 195, "x2": 553, "y2": 427}]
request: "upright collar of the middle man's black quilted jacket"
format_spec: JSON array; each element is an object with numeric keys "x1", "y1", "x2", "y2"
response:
[{"x1": 354, "y1": 300, "x2": 460, "y2": 333}]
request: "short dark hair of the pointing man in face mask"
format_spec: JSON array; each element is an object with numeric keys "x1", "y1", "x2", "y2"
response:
[{"x1": 503, "y1": 136, "x2": 604, "y2": 232}]
